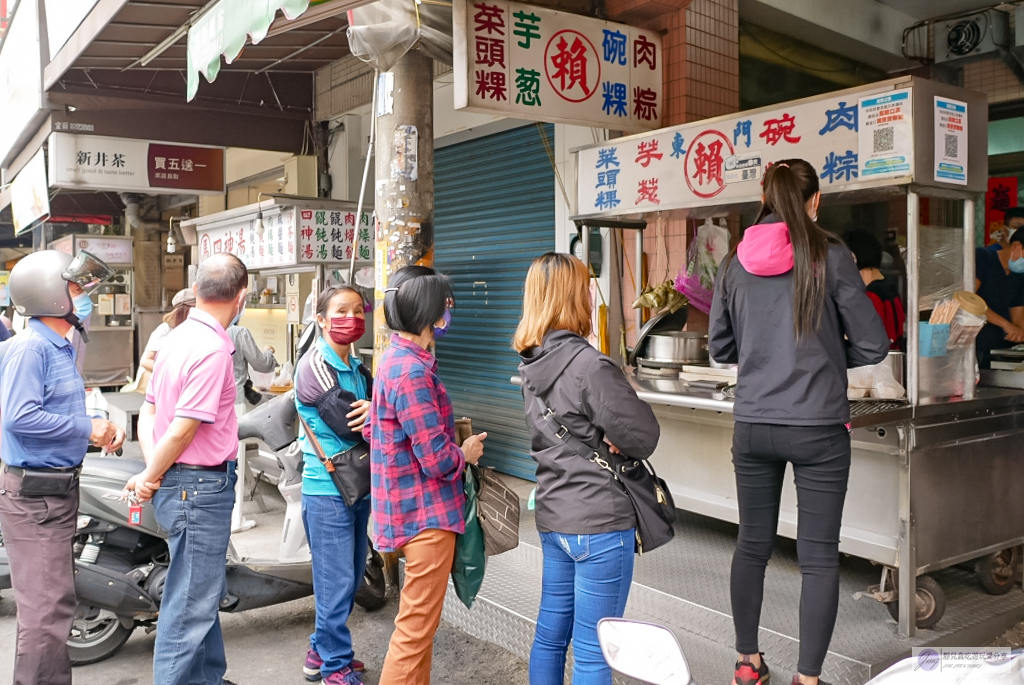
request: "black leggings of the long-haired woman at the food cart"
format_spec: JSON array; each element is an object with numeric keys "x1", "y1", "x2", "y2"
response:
[{"x1": 732, "y1": 421, "x2": 850, "y2": 676}]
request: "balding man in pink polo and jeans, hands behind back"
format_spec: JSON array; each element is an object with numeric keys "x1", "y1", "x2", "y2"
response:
[{"x1": 126, "y1": 254, "x2": 249, "y2": 685}]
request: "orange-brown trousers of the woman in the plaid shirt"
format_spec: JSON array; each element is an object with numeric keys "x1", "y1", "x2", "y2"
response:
[{"x1": 380, "y1": 528, "x2": 456, "y2": 685}]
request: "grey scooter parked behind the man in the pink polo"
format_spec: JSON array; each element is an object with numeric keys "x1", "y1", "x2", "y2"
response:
[{"x1": 0, "y1": 393, "x2": 387, "y2": 665}]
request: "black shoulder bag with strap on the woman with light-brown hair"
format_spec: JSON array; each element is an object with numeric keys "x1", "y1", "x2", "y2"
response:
[{"x1": 534, "y1": 397, "x2": 676, "y2": 554}]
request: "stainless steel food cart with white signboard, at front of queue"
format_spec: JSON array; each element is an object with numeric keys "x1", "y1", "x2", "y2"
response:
[{"x1": 574, "y1": 78, "x2": 1024, "y2": 636}]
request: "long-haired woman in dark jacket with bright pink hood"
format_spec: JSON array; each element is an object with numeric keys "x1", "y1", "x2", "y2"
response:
[{"x1": 709, "y1": 160, "x2": 889, "y2": 685}]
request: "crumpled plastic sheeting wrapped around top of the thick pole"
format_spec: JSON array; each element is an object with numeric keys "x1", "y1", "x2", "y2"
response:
[{"x1": 348, "y1": 0, "x2": 453, "y2": 72}]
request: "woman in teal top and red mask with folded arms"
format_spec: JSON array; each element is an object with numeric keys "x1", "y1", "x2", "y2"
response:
[{"x1": 295, "y1": 288, "x2": 373, "y2": 685}]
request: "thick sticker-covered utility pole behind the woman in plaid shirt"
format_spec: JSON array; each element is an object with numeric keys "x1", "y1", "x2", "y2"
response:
[{"x1": 374, "y1": 50, "x2": 434, "y2": 367}]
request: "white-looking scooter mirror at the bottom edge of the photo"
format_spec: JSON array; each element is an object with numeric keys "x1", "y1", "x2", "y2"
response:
[{"x1": 597, "y1": 618, "x2": 690, "y2": 685}]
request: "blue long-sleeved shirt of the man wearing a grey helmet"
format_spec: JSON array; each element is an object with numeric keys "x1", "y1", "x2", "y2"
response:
[{"x1": 0, "y1": 318, "x2": 92, "y2": 469}]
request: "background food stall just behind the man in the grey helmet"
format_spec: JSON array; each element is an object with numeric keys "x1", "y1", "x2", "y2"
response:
[{"x1": 48, "y1": 233, "x2": 135, "y2": 386}]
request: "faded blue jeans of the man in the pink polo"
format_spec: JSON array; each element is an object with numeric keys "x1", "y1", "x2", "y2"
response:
[{"x1": 153, "y1": 462, "x2": 236, "y2": 685}]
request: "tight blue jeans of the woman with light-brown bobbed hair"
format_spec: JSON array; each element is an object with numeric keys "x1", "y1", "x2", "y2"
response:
[{"x1": 529, "y1": 528, "x2": 635, "y2": 685}]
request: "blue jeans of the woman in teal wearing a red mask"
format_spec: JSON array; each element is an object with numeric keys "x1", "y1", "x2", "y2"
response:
[{"x1": 302, "y1": 495, "x2": 370, "y2": 678}]
